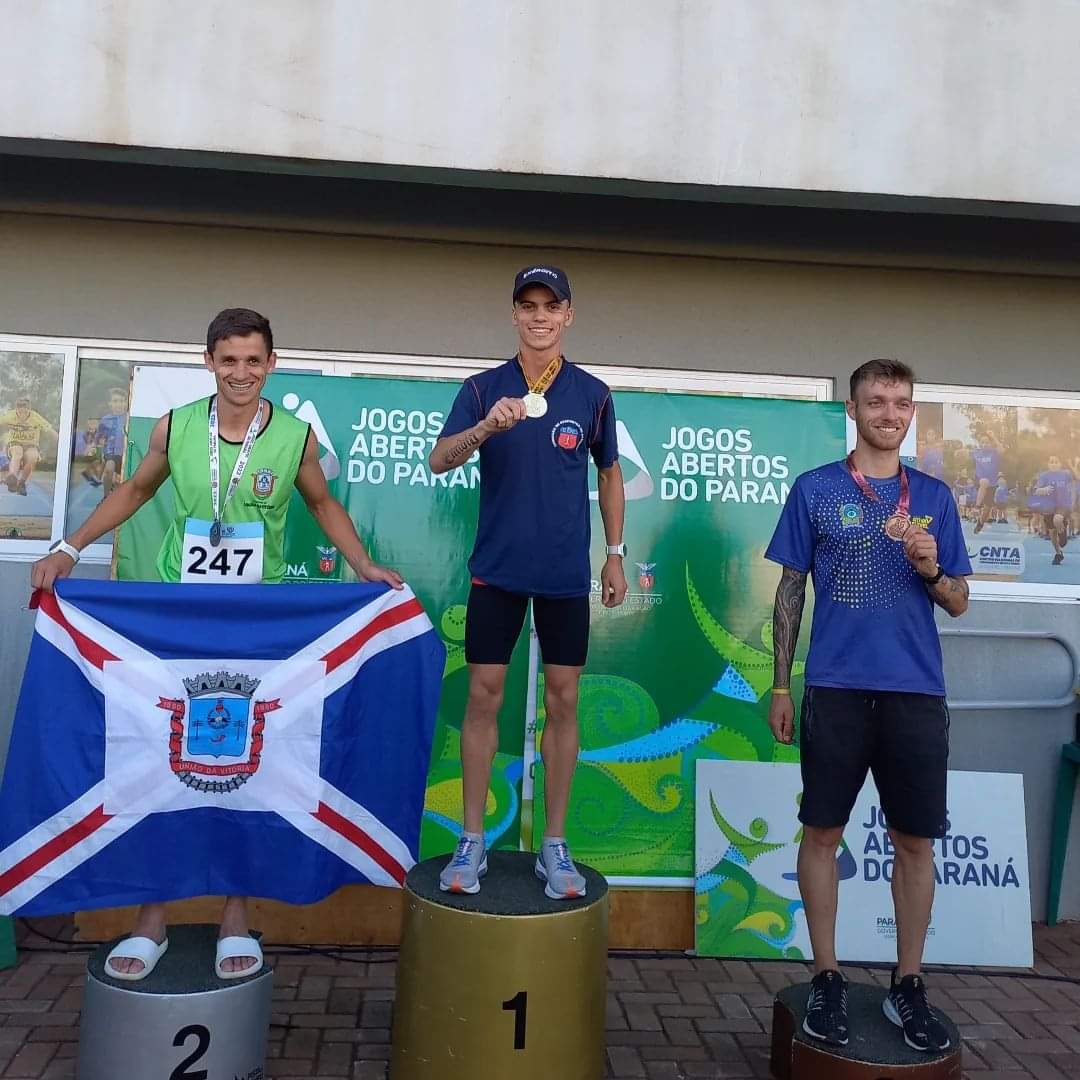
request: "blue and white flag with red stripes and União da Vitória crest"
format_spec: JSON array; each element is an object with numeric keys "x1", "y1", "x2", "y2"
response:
[{"x1": 0, "y1": 580, "x2": 445, "y2": 915}]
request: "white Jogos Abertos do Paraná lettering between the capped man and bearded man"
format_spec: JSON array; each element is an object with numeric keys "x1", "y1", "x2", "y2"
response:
[{"x1": 660, "y1": 427, "x2": 791, "y2": 505}]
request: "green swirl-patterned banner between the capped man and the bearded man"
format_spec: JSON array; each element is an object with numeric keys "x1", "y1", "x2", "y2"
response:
[{"x1": 535, "y1": 391, "x2": 843, "y2": 879}]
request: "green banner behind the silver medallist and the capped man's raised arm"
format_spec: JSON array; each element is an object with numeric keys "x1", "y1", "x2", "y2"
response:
[{"x1": 117, "y1": 368, "x2": 529, "y2": 858}]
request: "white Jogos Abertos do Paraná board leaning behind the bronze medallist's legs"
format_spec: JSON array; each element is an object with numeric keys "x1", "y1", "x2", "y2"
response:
[{"x1": 694, "y1": 761, "x2": 1032, "y2": 968}]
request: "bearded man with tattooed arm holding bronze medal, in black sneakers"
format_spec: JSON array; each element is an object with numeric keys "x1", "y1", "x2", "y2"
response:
[{"x1": 766, "y1": 360, "x2": 971, "y2": 1051}]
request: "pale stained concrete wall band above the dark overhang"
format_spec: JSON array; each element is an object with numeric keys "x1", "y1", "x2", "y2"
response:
[{"x1": 6, "y1": 0, "x2": 1080, "y2": 213}]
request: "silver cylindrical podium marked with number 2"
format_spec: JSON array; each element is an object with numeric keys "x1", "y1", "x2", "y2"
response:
[{"x1": 76, "y1": 923, "x2": 273, "y2": 1080}]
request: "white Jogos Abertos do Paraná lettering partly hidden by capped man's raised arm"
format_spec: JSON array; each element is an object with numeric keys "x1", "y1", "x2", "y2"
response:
[{"x1": 346, "y1": 405, "x2": 480, "y2": 489}]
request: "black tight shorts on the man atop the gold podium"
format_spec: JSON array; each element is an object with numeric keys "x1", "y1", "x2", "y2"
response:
[{"x1": 465, "y1": 584, "x2": 589, "y2": 667}]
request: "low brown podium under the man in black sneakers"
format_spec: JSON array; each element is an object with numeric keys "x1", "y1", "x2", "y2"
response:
[{"x1": 770, "y1": 982, "x2": 960, "y2": 1080}]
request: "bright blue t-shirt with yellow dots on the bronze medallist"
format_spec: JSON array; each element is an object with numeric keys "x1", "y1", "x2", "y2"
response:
[{"x1": 765, "y1": 461, "x2": 971, "y2": 698}]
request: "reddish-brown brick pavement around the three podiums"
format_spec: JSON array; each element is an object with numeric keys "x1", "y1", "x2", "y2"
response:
[{"x1": 0, "y1": 922, "x2": 1080, "y2": 1080}]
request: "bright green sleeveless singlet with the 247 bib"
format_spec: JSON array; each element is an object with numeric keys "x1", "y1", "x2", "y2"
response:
[{"x1": 158, "y1": 397, "x2": 310, "y2": 583}]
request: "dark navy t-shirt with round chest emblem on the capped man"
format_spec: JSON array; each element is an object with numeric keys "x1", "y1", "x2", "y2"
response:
[{"x1": 440, "y1": 359, "x2": 619, "y2": 598}]
